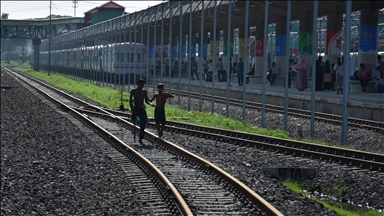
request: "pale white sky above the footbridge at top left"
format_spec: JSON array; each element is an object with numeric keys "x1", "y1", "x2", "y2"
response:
[{"x1": 0, "y1": 0, "x2": 162, "y2": 19}]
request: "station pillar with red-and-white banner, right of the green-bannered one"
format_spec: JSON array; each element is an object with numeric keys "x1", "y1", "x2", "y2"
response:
[{"x1": 324, "y1": 12, "x2": 343, "y2": 65}]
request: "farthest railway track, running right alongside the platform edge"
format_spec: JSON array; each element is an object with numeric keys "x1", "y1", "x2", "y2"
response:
[{"x1": 147, "y1": 86, "x2": 384, "y2": 134}]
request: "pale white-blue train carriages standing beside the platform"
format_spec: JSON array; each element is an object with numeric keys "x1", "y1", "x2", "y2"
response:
[{"x1": 40, "y1": 42, "x2": 148, "y2": 83}]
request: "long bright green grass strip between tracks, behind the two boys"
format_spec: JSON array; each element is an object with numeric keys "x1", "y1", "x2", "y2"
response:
[{"x1": 11, "y1": 65, "x2": 334, "y2": 145}]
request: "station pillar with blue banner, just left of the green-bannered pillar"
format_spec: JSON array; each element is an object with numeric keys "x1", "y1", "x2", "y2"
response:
[{"x1": 271, "y1": 21, "x2": 287, "y2": 77}]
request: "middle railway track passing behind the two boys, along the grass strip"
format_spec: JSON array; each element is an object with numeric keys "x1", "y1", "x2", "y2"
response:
[{"x1": 4, "y1": 66, "x2": 384, "y2": 172}]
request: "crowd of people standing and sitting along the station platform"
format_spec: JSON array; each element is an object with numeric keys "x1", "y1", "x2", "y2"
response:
[{"x1": 148, "y1": 55, "x2": 384, "y2": 94}]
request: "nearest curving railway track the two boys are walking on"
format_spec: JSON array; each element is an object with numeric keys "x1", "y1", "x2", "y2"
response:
[{"x1": 2, "y1": 67, "x2": 281, "y2": 215}]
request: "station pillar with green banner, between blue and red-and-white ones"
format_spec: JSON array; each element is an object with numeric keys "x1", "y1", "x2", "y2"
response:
[{"x1": 299, "y1": 16, "x2": 316, "y2": 77}]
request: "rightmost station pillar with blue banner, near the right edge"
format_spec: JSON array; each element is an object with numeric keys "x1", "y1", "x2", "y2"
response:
[{"x1": 356, "y1": 7, "x2": 379, "y2": 70}]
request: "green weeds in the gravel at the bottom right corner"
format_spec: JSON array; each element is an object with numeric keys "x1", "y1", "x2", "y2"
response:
[{"x1": 283, "y1": 179, "x2": 384, "y2": 216}]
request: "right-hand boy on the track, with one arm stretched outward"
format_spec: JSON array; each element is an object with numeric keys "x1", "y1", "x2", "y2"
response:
[{"x1": 150, "y1": 83, "x2": 173, "y2": 138}]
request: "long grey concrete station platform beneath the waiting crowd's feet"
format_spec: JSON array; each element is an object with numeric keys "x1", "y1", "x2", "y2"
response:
[{"x1": 149, "y1": 77, "x2": 384, "y2": 122}]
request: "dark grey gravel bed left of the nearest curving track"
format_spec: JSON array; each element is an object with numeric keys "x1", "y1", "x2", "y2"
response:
[{"x1": 1, "y1": 72, "x2": 145, "y2": 215}]
